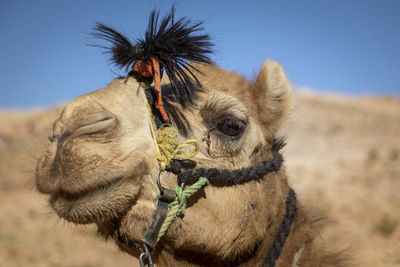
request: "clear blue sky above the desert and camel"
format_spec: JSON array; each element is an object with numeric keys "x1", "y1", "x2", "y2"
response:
[{"x1": 0, "y1": 0, "x2": 400, "y2": 108}]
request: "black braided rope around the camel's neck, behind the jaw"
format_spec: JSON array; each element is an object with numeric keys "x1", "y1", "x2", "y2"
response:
[{"x1": 263, "y1": 188, "x2": 297, "y2": 267}]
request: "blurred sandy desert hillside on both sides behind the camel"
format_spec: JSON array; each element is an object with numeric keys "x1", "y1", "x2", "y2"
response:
[{"x1": 0, "y1": 90, "x2": 400, "y2": 267}]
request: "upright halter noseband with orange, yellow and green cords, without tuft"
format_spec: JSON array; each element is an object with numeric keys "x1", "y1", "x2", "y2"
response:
[{"x1": 138, "y1": 79, "x2": 208, "y2": 267}]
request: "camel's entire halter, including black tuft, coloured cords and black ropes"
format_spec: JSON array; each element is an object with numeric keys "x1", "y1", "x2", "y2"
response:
[{"x1": 92, "y1": 9, "x2": 297, "y2": 267}]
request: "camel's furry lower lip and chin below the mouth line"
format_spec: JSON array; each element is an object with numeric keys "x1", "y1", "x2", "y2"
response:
[{"x1": 49, "y1": 178, "x2": 139, "y2": 224}]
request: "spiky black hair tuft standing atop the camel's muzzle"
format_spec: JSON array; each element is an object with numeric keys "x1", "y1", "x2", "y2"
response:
[{"x1": 91, "y1": 8, "x2": 213, "y2": 107}]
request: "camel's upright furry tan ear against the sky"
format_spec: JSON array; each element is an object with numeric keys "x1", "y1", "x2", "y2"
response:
[{"x1": 254, "y1": 61, "x2": 293, "y2": 136}]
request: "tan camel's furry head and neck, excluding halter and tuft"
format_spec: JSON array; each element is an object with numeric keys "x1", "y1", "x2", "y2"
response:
[{"x1": 36, "y1": 9, "x2": 344, "y2": 266}]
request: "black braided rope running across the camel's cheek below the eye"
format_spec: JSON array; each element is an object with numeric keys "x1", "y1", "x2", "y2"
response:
[{"x1": 167, "y1": 152, "x2": 283, "y2": 186}]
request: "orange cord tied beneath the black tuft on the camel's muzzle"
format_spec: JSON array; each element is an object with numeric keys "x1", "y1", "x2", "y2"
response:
[{"x1": 132, "y1": 57, "x2": 169, "y2": 122}]
